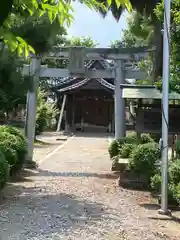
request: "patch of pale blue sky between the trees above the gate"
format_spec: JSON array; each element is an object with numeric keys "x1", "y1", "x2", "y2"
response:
[{"x1": 68, "y1": 2, "x2": 128, "y2": 47}]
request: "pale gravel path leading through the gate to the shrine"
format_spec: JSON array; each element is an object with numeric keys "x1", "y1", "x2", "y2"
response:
[{"x1": 0, "y1": 132, "x2": 180, "y2": 240}]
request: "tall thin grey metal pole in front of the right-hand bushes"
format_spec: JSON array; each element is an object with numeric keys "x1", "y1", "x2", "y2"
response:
[{"x1": 159, "y1": 0, "x2": 171, "y2": 214}]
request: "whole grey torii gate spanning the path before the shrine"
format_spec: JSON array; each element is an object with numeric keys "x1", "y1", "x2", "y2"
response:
[{"x1": 23, "y1": 47, "x2": 153, "y2": 167}]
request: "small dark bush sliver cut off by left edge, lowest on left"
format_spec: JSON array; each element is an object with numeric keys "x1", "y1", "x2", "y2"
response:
[{"x1": 0, "y1": 152, "x2": 9, "y2": 189}]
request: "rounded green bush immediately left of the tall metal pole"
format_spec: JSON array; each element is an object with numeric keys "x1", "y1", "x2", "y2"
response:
[{"x1": 129, "y1": 143, "x2": 160, "y2": 180}]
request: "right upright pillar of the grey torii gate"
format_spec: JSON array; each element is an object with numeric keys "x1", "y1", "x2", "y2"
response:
[{"x1": 114, "y1": 60, "x2": 125, "y2": 139}]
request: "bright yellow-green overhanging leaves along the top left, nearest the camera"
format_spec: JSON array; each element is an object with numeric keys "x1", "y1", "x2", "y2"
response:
[{"x1": 0, "y1": 0, "x2": 131, "y2": 57}]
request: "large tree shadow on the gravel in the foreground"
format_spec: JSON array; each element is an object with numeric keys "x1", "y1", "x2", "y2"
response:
[{"x1": 0, "y1": 181, "x2": 120, "y2": 239}]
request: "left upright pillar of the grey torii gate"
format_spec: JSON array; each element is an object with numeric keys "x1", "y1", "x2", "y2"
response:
[{"x1": 26, "y1": 57, "x2": 40, "y2": 167}]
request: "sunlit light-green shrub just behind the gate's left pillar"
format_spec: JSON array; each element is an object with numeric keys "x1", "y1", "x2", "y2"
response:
[{"x1": 36, "y1": 90, "x2": 58, "y2": 134}]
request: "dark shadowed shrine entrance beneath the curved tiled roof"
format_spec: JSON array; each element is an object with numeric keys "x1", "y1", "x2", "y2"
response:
[{"x1": 66, "y1": 90, "x2": 114, "y2": 132}]
